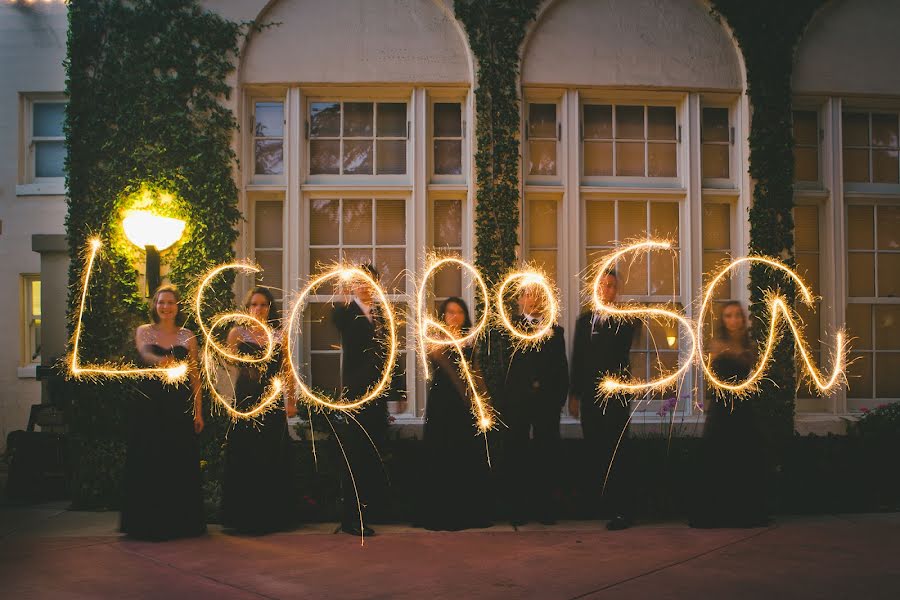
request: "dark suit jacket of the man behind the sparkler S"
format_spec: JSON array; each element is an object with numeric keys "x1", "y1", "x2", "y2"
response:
[{"x1": 572, "y1": 311, "x2": 638, "y2": 400}]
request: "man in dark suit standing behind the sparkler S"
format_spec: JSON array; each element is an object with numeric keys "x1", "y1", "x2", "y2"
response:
[{"x1": 569, "y1": 271, "x2": 639, "y2": 530}]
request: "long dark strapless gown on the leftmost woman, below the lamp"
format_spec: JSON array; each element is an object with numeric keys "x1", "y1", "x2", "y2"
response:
[{"x1": 120, "y1": 344, "x2": 206, "y2": 540}]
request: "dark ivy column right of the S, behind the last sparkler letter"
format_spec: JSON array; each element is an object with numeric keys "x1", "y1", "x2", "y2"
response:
[{"x1": 712, "y1": 0, "x2": 823, "y2": 454}]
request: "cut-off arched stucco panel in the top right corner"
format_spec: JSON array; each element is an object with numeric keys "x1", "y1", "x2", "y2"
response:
[{"x1": 793, "y1": 0, "x2": 900, "y2": 95}]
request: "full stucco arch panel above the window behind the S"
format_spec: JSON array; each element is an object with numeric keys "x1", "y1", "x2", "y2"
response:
[{"x1": 522, "y1": 0, "x2": 741, "y2": 90}]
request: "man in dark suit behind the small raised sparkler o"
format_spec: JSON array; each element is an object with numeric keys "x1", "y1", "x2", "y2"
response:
[{"x1": 500, "y1": 287, "x2": 569, "y2": 525}]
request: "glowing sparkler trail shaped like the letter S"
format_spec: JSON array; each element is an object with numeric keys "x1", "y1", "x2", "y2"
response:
[{"x1": 592, "y1": 240, "x2": 697, "y2": 397}]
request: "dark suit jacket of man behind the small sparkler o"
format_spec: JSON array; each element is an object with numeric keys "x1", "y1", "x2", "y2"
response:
[{"x1": 503, "y1": 317, "x2": 569, "y2": 411}]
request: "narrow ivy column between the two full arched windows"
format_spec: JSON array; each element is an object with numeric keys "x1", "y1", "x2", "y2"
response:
[{"x1": 454, "y1": 0, "x2": 539, "y2": 390}]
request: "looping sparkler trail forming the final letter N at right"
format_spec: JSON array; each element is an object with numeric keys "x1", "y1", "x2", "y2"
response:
[{"x1": 697, "y1": 256, "x2": 848, "y2": 396}]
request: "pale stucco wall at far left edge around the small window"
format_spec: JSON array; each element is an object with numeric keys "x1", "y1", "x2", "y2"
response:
[{"x1": 0, "y1": 2, "x2": 67, "y2": 451}]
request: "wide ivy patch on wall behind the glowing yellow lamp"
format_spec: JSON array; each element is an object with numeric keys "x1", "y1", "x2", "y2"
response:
[{"x1": 65, "y1": 0, "x2": 249, "y2": 506}]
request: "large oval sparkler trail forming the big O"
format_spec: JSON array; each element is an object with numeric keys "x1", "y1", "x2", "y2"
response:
[{"x1": 285, "y1": 265, "x2": 398, "y2": 412}]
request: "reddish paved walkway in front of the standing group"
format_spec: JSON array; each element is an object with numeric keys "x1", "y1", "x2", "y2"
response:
[{"x1": 0, "y1": 504, "x2": 900, "y2": 600}]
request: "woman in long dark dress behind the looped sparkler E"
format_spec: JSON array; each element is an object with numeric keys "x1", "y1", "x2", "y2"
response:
[{"x1": 223, "y1": 287, "x2": 296, "y2": 534}]
